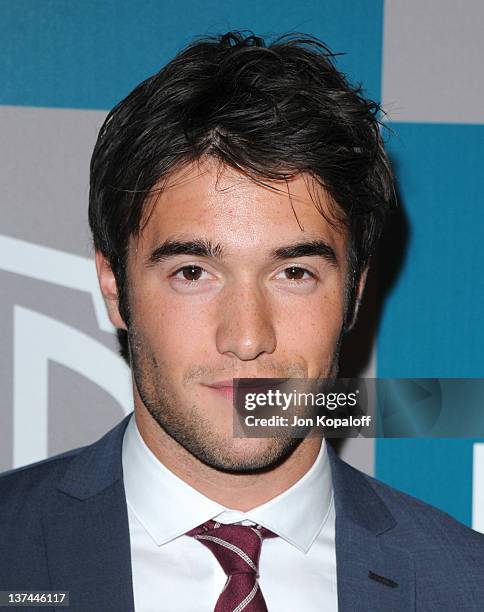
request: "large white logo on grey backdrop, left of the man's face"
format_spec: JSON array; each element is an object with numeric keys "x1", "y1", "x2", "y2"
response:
[{"x1": 0, "y1": 235, "x2": 132, "y2": 467}]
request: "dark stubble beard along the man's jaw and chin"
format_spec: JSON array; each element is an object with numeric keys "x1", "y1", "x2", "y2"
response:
[{"x1": 128, "y1": 324, "x2": 341, "y2": 474}]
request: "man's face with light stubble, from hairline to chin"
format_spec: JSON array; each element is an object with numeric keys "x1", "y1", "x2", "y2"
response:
[{"x1": 103, "y1": 161, "x2": 347, "y2": 472}]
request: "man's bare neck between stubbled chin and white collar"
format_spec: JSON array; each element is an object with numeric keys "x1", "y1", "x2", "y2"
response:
[{"x1": 135, "y1": 406, "x2": 321, "y2": 512}]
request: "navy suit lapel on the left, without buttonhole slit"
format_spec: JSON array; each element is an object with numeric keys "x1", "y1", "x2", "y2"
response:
[{"x1": 43, "y1": 417, "x2": 134, "y2": 612}]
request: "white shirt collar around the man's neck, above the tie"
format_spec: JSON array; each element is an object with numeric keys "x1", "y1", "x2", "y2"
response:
[{"x1": 122, "y1": 414, "x2": 333, "y2": 552}]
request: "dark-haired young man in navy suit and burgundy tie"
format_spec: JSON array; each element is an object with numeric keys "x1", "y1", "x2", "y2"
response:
[{"x1": 0, "y1": 33, "x2": 484, "y2": 612}]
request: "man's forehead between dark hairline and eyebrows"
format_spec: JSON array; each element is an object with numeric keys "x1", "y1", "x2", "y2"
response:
[{"x1": 136, "y1": 159, "x2": 346, "y2": 251}]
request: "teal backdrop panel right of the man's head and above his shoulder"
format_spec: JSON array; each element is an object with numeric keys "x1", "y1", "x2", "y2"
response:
[{"x1": 376, "y1": 123, "x2": 484, "y2": 525}]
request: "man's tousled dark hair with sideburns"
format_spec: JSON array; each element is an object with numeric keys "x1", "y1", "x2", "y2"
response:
[{"x1": 89, "y1": 32, "x2": 395, "y2": 327}]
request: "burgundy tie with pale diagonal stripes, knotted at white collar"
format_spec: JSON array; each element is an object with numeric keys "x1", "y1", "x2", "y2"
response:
[{"x1": 187, "y1": 520, "x2": 277, "y2": 612}]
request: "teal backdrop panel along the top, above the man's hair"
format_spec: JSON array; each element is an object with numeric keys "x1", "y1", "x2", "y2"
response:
[{"x1": 0, "y1": 0, "x2": 383, "y2": 109}]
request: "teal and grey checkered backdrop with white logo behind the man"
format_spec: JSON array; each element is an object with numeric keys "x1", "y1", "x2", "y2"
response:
[{"x1": 0, "y1": 0, "x2": 484, "y2": 532}]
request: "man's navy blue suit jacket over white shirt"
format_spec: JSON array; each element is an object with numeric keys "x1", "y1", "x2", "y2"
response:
[{"x1": 0, "y1": 417, "x2": 484, "y2": 612}]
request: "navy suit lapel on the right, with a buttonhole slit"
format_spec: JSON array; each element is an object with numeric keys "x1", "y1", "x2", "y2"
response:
[{"x1": 328, "y1": 444, "x2": 415, "y2": 612}]
